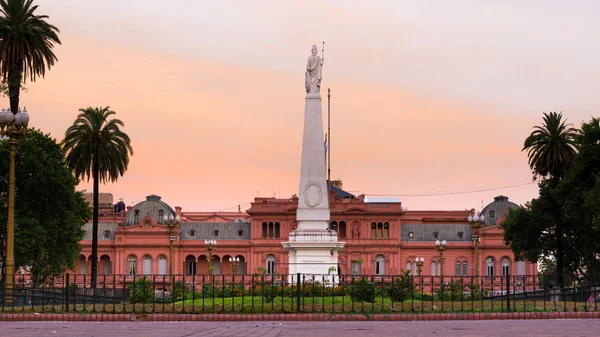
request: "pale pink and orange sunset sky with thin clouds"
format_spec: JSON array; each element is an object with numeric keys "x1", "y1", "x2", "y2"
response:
[{"x1": 17, "y1": 0, "x2": 600, "y2": 211}]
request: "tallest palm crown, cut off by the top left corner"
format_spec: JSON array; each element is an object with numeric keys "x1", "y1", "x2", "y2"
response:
[{"x1": 0, "y1": 0, "x2": 60, "y2": 113}]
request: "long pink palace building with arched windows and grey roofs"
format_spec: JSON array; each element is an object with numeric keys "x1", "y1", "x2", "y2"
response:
[{"x1": 73, "y1": 182, "x2": 537, "y2": 276}]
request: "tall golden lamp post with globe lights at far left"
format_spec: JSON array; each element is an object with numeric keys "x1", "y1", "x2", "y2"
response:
[{"x1": 0, "y1": 108, "x2": 29, "y2": 303}]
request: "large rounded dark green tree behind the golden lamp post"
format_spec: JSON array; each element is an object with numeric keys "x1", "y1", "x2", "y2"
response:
[{"x1": 0, "y1": 129, "x2": 91, "y2": 284}]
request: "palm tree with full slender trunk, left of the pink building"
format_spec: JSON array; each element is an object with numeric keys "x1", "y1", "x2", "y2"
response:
[{"x1": 61, "y1": 106, "x2": 133, "y2": 288}]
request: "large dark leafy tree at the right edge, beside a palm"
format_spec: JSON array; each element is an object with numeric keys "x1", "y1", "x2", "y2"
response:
[{"x1": 502, "y1": 118, "x2": 600, "y2": 278}]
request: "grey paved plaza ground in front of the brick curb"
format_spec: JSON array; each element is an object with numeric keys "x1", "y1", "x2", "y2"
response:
[{"x1": 0, "y1": 319, "x2": 600, "y2": 337}]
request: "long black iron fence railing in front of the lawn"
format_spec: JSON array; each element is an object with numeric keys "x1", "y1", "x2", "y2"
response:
[{"x1": 0, "y1": 274, "x2": 600, "y2": 313}]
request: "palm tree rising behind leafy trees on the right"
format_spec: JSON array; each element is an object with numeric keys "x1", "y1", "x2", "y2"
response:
[{"x1": 521, "y1": 112, "x2": 580, "y2": 287}]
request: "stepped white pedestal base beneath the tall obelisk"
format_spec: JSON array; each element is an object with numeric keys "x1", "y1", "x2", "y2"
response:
[{"x1": 282, "y1": 229, "x2": 346, "y2": 277}]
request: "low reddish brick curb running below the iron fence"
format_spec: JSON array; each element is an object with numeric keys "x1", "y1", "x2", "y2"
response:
[{"x1": 0, "y1": 312, "x2": 600, "y2": 322}]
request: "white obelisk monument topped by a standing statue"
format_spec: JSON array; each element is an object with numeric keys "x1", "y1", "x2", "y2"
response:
[{"x1": 282, "y1": 46, "x2": 345, "y2": 274}]
